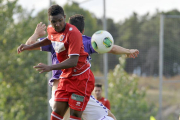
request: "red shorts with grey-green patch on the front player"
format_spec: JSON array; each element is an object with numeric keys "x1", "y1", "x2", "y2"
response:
[{"x1": 54, "y1": 69, "x2": 95, "y2": 111}]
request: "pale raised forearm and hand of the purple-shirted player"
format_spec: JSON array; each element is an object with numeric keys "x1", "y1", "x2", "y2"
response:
[{"x1": 26, "y1": 22, "x2": 46, "y2": 50}]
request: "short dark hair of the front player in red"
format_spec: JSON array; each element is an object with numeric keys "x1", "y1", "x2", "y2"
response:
[{"x1": 48, "y1": 5, "x2": 64, "y2": 16}]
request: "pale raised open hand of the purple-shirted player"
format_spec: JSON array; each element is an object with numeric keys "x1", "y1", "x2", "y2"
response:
[{"x1": 34, "y1": 22, "x2": 46, "y2": 37}]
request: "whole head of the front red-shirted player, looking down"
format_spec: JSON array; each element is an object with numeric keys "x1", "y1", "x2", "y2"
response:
[{"x1": 48, "y1": 5, "x2": 66, "y2": 32}]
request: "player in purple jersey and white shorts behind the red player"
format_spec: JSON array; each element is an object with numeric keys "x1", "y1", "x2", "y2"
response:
[{"x1": 18, "y1": 14, "x2": 138, "y2": 120}]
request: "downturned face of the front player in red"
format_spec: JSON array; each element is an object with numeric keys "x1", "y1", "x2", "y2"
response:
[{"x1": 49, "y1": 14, "x2": 66, "y2": 32}]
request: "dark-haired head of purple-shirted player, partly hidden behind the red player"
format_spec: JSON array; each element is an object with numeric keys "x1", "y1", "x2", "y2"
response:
[{"x1": 69, "y1": 14, "x2": 84, "y2": 34}]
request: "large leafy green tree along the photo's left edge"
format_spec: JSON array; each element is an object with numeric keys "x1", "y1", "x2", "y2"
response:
[{"x1": 0, "y1": 0, "x2": 47, "y2": 120}]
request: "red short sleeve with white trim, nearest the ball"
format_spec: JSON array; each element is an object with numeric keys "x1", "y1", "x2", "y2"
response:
[{"x1": 68, "y1": 31, "x2": 83, "y2": 55}]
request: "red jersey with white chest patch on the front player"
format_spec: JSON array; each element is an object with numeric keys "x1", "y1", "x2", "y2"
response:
[{"x1": 47, "y1": 23, "x2": 90, "y2": 78}]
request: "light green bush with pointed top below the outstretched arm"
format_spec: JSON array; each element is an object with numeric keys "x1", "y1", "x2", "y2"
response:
[{"x1": 108, "y1": 56, "x2": 155, "y2": 120}]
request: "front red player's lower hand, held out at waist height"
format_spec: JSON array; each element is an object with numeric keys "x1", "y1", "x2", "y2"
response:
[{"x1": 33, "y1": 63, "x2": 51, "y2": 73}]
